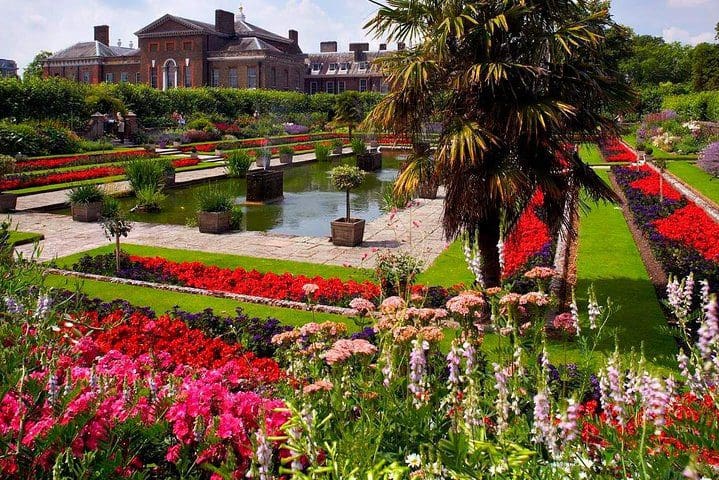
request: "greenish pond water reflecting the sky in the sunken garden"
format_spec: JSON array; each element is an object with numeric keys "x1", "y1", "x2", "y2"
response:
[{"x1": 63, "y1": 156, "x2": 399, "y2": 237}]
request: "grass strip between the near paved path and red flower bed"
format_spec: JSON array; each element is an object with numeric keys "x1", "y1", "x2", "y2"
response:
[{"x1": 56, "y1": 243, "x2": 372, "y2": 281}]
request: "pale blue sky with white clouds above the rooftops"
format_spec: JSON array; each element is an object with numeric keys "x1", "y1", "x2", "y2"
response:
[{"x1": 0, "y1": 0, "x2": 719, "y2": 71}]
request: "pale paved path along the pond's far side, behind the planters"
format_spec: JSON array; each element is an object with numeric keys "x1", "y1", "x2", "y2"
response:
[{"x1": 17, "y1": 148, "x2": 352, "y2": 211}]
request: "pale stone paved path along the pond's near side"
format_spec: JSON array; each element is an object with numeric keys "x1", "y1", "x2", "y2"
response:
[{"x1": 11, "y1": 192, "x2": 446, "y2": 268}]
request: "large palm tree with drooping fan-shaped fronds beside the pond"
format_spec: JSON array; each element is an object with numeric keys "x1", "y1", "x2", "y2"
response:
[{"x1": 365, "y1": 0, "x2": 634, "y2": 286}]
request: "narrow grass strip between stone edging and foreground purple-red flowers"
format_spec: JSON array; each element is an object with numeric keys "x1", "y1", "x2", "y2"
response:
[{"x1": 45, "y1": 275, "x2": 359, "y2": 331}]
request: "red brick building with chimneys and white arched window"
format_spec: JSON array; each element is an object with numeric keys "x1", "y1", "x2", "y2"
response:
[{"x1": 43, "y1": 9, "x2": 400, "y2": 93}]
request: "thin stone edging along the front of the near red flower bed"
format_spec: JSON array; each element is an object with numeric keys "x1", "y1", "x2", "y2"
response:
[{"x1": 45, "y1": 268, "x2": 359, "y2": 317}]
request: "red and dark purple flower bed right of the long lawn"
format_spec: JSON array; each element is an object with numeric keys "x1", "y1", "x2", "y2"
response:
[{"x1": 613, "y1": 166, "x2": 719, "y2": 285}]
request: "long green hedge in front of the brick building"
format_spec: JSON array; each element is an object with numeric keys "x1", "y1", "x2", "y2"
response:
[{"x1": 0, "y1": 78, "x2": 381, "y2": 125}]
